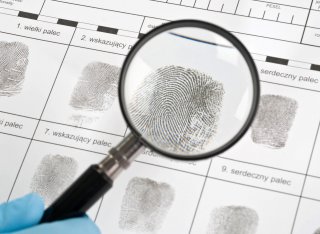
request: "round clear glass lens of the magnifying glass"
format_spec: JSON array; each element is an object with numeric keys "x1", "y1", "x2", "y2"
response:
[{"x1": 121, "y1": 26, "x2": 257, "y2": 158}]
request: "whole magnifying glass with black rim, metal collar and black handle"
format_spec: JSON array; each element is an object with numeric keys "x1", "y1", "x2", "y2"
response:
[{"x1": 41, "y1": 20, "x2": 260, "y2": 222}]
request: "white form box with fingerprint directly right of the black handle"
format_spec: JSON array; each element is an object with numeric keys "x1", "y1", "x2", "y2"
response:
[{"x1": 97, "y1": 163, "x2": 204, "y2": 234}]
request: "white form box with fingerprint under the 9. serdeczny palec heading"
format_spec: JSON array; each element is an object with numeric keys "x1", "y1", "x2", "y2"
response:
[{"x1": 191, "y1": 179, "x2": 299, "y2": 234}]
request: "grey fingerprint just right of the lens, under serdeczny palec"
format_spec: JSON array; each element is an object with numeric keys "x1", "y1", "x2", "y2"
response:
[{"x1": 251, "y1": 95, "x2": 298, "y2": 149}]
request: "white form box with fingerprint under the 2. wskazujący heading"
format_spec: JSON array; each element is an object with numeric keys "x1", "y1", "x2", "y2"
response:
[{"x1": 43, "y1": 47, "x2": 126, "y2": 136}]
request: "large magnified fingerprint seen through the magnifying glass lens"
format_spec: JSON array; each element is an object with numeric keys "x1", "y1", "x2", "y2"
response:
[{"x1": 129, "y1": 66, "x2": 224, "y2": 153}]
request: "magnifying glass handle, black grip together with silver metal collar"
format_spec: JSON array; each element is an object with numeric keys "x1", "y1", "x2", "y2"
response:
[{"x1": 40, "y1": 134, "x2": 144, "y2": 223}]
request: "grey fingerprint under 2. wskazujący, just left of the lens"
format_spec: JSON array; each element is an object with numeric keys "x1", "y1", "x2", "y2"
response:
[{"x1": 70, "y1": 62, "x2": 120, "y2": 111}]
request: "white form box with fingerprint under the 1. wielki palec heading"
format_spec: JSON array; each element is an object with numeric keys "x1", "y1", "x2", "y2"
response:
[{"x1": 0, "y1": 33, "x2": 67, "y2": 118}]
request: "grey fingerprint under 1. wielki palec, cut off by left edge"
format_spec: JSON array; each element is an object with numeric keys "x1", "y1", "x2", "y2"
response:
[{"x1": 0, "y1": 41, "x2": 29, "y2": 97}]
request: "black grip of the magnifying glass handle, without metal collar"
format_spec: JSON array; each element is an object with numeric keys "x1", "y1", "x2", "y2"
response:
[{"x1": 40, "y1": 165, "x2": 113, "y2": 223}]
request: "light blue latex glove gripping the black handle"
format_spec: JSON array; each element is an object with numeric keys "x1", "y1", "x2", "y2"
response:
[{"x1": 0, "y1": 194, "x2": 100, "y2": 234}]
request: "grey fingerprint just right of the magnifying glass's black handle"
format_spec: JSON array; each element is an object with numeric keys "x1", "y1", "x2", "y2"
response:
[{"x1": 119, "y1": 177, "x2": 174, "y2": 233}]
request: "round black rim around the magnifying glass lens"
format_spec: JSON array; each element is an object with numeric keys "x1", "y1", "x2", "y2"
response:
[{"x1": 118, "y1": 20, "x2": 260, "y2": 160}]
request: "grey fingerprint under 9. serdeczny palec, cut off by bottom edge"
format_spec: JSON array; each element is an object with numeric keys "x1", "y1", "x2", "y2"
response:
[{"x1": 207, "y1": 206, "x2": 259, "y2": 234}]
